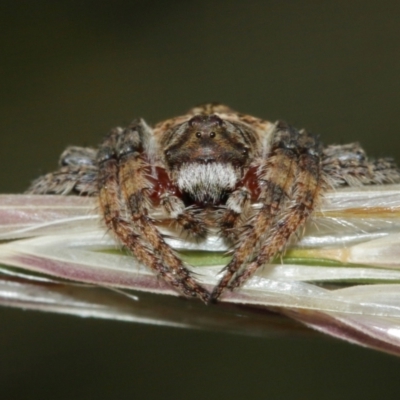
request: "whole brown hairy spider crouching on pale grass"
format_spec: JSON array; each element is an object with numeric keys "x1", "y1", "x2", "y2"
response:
[{"x1": 28, "y1": 104, "x2": 400, "y2": 303}]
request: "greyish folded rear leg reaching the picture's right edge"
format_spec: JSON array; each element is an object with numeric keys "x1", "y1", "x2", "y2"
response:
[{"x1": 322, "y1": 143, "x2": 400, "y2": 187}]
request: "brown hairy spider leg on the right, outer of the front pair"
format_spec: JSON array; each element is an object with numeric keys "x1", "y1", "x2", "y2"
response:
[{"x1": 228, "y1": 131, "x2": 326, "y2": 290}]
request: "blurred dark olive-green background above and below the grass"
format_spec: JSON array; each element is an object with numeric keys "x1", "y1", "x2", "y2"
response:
[{"x1": 0, "y1": 0, "x2": 400, "y2": 400}]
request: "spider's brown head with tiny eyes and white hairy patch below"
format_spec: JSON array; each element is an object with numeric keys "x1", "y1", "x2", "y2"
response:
[{"x1": 163, "y1": 114, "x2": 254, "y2": 203}]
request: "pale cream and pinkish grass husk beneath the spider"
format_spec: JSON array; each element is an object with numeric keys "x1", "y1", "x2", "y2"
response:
[{"x1": 0, "y1": 185, "x2": 400, "y2": 354}]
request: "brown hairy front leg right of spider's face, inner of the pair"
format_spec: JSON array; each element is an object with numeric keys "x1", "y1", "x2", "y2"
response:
[{"x1": 211, "y1": 122, "x2": 301, "y2": 299}]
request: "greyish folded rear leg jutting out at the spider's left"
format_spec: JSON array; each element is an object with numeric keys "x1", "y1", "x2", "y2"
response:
[{"x1": 27, "y1": 147, "x2": 97, "y2": 196}]
